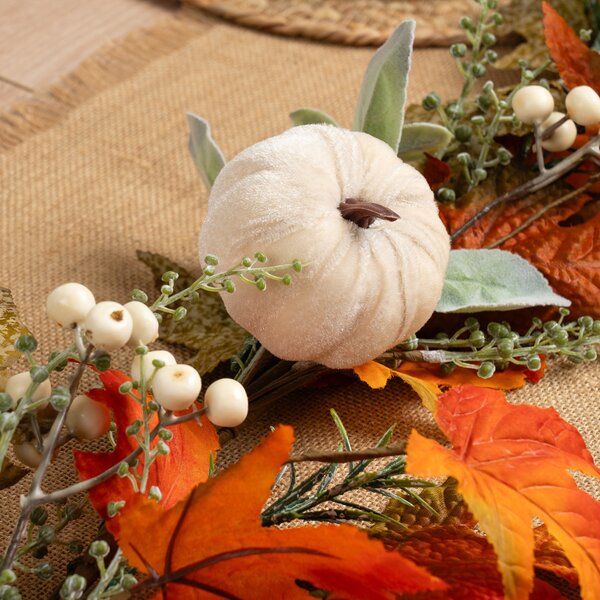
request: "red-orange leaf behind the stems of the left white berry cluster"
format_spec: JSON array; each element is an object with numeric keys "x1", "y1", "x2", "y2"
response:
[{"x1": 74, "y1": 370, "x2": 219, "y2": 532}]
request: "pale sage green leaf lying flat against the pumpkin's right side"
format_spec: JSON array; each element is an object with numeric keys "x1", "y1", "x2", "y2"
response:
[{"x1": 436, "y1": 250, "x2": 571, "y2": 313}]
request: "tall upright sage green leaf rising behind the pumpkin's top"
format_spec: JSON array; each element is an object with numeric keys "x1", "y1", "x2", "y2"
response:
[{"x1": 353, "y1": 20, "x2": 415, "y2": 152}]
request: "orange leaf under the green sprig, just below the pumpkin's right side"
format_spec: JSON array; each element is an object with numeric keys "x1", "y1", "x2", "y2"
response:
[{"x1": 354, "y1": 360, "x2": 528, "y2": 412}]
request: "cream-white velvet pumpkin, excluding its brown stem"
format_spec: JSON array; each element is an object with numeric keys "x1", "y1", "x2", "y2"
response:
[{"x1": 200, "y1": 125, "x2": 449, "y2": 368}]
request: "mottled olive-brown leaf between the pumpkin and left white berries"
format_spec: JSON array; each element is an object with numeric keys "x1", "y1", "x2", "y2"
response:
[{"x1": 137, "y1": 250, "x2": 248, "y2": 375}]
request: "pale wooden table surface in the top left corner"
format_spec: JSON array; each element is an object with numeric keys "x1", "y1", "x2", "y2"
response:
[{"x1": 0, "y1": 0, "x2": 178, "y2": 109}]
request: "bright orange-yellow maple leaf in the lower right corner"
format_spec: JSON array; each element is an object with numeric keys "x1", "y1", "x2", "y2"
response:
[{"x1": 406, "y1": 386, "x2": 600, "y2": 600}]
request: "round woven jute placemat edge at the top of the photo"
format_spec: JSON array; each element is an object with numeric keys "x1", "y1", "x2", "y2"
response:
[{"x1": 184, "y1": 0, "x2": 492, "y2": 47}]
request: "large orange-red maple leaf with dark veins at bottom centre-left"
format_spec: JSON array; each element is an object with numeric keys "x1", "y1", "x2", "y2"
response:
[{"x1": 118, "y1": 426, "x2": 446, "y2": 600}]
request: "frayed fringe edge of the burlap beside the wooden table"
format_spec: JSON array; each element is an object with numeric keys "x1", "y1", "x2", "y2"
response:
[{"x1": 0, "y1": 11, "x2": 202, "y2": 152}]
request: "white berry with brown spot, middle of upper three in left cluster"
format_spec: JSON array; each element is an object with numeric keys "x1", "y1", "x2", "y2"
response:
[{"x1": 83, "y1": 300, "x2": 133, "y2": 351}]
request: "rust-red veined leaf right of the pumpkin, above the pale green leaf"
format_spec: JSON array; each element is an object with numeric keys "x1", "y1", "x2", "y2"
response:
[{"x1": 440, "y1": 189, "x2": 600, "y2": 316}]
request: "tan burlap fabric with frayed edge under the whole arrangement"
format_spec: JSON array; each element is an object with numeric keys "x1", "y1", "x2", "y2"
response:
[{"x1": 0, "y1": 7, "x2": 600, "y2": 599}]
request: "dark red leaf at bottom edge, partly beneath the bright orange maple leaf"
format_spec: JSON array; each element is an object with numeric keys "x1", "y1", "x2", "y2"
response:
[{"x1": 388, "y1": 525, "x2": 563, "y2": 600}]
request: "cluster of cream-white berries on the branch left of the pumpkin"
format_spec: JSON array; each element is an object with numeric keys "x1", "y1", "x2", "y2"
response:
[{"x1": 4, "y1": 283, "x2": 248, "y2": 467}]
